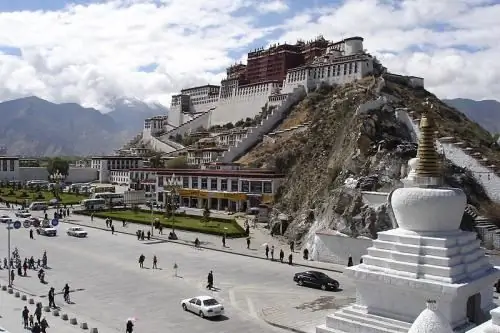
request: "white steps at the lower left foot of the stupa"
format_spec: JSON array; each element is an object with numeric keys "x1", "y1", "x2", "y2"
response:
[{"x1": 316, "y1": 304, "x2": 411, "y2": 333}]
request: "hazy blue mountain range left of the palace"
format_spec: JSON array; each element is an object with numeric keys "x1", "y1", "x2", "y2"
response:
[{"x1": 0, "y1": 96, "x2": 168, "y2": 157}]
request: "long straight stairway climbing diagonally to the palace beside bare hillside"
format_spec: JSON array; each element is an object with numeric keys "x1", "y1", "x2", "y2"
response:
[{"x1": 218, "y1": 86, "x2": 307, "y2": 163}]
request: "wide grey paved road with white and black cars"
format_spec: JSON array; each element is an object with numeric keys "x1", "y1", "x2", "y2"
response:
[{"x1": 0, "y1": 211, "x2": 355, "y2": 333}]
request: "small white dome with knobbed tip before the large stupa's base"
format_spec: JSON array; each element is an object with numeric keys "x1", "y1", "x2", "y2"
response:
[{"x1": 408, "y1": 301, "x2": 453, "y2": 333}]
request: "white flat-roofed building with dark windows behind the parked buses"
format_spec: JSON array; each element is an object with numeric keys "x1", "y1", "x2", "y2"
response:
[{"x1": 91, "y1": 156, "x2": 144, "y2": 183}]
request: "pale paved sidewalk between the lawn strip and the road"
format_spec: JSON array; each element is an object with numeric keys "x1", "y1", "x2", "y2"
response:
[{"x1": 55, "y1": 210, "x2": 344, "y2": 273}]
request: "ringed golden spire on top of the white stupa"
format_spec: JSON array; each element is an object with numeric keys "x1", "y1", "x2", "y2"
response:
[{"x1": 416, "y1": 113, "x2": 441, "y2": 178}]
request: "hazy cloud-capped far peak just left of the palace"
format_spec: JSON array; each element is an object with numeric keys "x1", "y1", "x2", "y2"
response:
[{"x1": 107, "y1": 98, "x2": 168, "y2": 132}]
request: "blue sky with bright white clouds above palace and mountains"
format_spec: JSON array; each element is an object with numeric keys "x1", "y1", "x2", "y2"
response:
[{"x1": 0, "y1": 0, "x2": 500, "y2": 109}]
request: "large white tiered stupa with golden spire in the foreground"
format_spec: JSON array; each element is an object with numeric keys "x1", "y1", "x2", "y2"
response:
[{"x1": 316, "y1": 116, "x2": 500, "y2": 333}]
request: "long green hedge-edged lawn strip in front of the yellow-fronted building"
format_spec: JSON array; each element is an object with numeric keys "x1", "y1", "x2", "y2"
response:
[{"x1": 75, "y1": 210, "x2": 245, "y2": 237}]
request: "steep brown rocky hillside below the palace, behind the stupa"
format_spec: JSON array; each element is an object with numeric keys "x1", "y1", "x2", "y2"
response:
[{"x1": 239, "y1": 74, "x2": 500, "y2": 240}]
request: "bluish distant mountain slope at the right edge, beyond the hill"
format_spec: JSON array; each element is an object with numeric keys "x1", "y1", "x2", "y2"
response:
[{"x1": 443, "y1": 98, "x2": 500, "y2": 134}]
